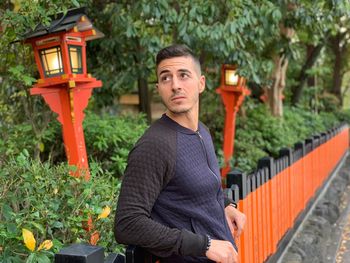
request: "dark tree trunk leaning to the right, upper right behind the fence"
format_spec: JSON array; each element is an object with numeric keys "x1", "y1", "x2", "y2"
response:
[{"x1": 292, "y1": 44, "x2": 323, "y2": 105}]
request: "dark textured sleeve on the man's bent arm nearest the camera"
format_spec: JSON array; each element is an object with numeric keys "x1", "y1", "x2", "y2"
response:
[{"x1": 114, "y1": 141, "x2": 207, "y2": 257}]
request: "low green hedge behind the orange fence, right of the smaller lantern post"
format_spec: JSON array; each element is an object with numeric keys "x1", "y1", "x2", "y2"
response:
[{"x1": 231, "y1": 104, "x2": 350, "y2": 172}]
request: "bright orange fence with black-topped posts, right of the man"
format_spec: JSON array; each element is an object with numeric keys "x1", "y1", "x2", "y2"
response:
[{"x1": 227, "y1": 125, "x2": 349, "y2": 263}]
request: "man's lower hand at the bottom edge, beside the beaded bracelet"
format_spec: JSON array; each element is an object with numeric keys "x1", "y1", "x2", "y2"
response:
[{"x1": 205, "y1": 240, "x2": 238, "y2": 263}]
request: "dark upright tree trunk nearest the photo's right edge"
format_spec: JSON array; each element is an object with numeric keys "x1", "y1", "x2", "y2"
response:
[{"x1": 330, "y1": 33, "x2": 346, "y2": 105}]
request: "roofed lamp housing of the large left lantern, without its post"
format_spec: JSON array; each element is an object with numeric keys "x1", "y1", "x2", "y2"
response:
[{"x1": 23, "y1": 8, "x2": 103, "y2": 81}]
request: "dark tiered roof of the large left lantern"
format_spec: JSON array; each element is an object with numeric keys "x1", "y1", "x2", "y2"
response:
[{"x1": 23, "y1": 7, "x2": 104, "y2": 41}]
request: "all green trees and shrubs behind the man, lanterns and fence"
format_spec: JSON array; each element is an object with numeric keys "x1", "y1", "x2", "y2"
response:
[{"x1": 0, "y1": 0, "x2": 350, "y2": 262}]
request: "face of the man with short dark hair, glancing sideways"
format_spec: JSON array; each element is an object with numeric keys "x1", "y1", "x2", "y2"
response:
[{"x1": 157, "y1": 57, "x2": 205, "y2": 114}]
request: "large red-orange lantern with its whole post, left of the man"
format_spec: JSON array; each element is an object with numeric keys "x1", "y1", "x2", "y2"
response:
[{"x1": 24, "y1": 8, "x2": 103, "y2": 180}]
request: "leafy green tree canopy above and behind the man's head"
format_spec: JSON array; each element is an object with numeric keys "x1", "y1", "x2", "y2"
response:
[{"x1": 89, "y1": 0, "x2": 281, "y2": 117}]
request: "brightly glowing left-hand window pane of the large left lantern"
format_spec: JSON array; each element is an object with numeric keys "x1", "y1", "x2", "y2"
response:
[{"x1": 40, "y1": 46, "x2": 64, "y2": 77}]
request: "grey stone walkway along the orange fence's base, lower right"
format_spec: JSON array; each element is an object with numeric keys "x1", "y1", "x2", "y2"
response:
[{"x1": 278, "y1": 156, "x2": 350, "y2": 263}]
